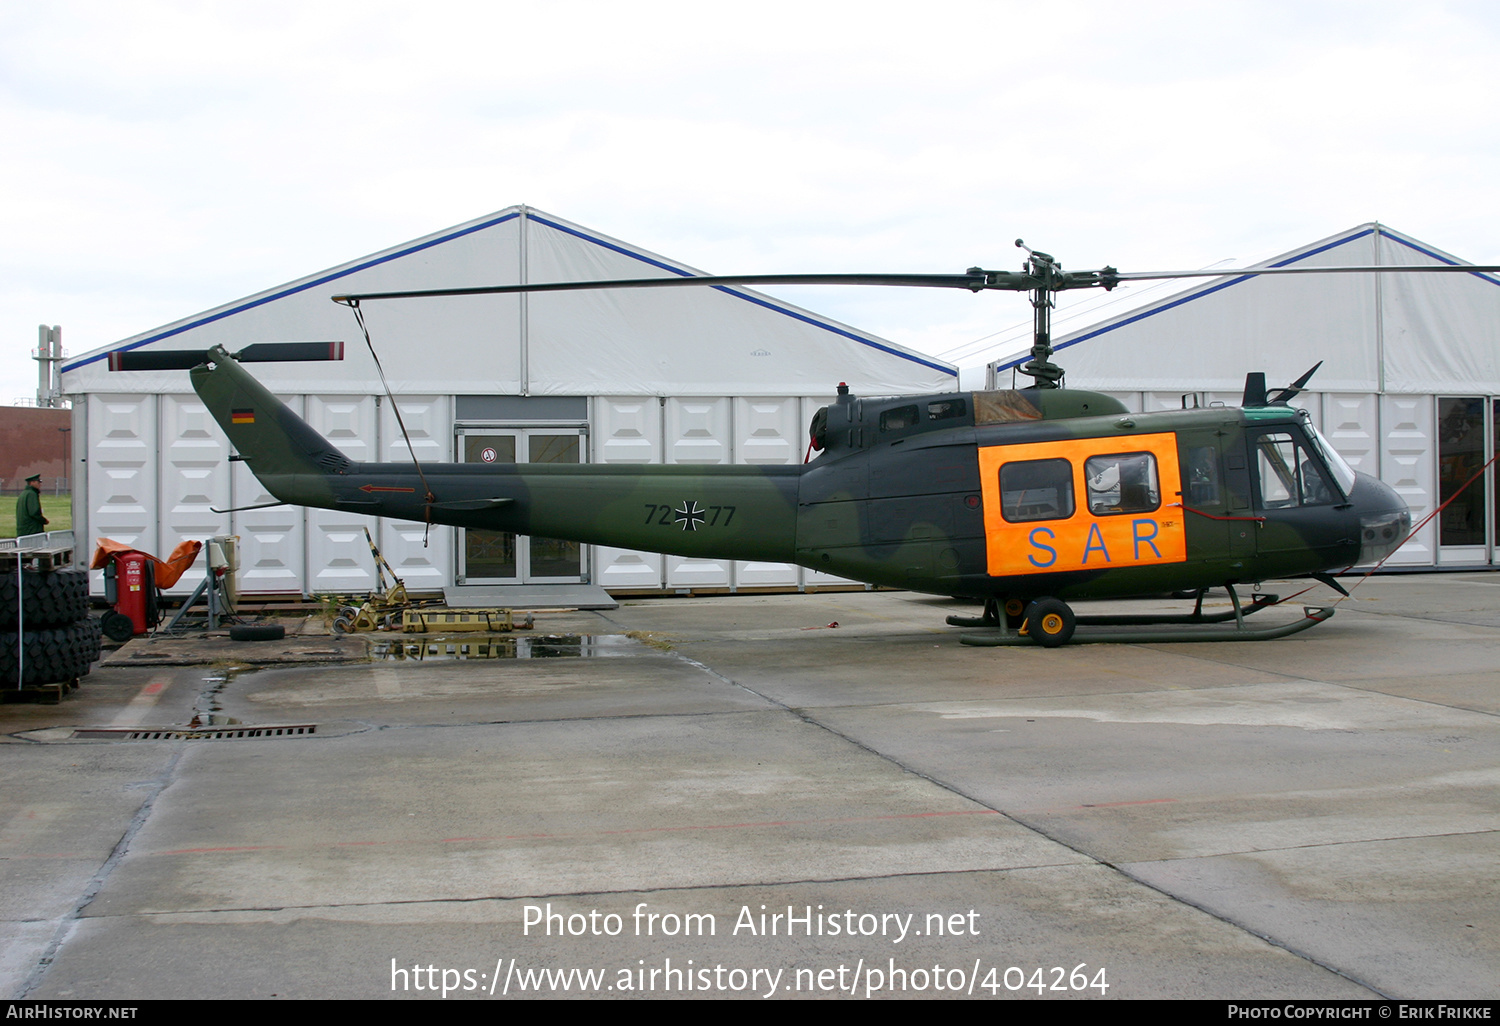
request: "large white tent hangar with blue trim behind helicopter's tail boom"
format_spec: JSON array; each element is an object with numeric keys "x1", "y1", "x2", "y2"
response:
[{"x1": 63, "y1": 207, "x2": 957, "y2": 594}]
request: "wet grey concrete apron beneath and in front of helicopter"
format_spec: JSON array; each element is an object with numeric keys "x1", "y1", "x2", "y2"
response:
[{"x1": 0, "y1": 575, "x2": 1500, "y2": 999}]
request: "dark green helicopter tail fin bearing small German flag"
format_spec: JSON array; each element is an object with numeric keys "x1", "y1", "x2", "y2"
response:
[{"x1": 191, "y1": 347, "x2": 353, "y2": 507}]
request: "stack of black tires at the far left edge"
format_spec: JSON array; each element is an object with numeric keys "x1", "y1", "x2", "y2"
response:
[{"x1": 0, "y1": 566, "x2": 99, "y2": 689}]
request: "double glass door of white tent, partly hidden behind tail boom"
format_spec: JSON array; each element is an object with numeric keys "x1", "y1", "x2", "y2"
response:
[{"x1": 456, "y1": 428, "x2": 584, "y2": 584}]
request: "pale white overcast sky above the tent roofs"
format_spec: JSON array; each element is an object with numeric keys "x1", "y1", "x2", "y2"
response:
[{"x1": 0, "y1": 0, "x2": 1500, "y2": 404}]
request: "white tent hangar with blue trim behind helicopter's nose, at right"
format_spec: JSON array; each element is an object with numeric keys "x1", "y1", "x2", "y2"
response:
[{"x1": 990, "y1": 224, "x2": 1500, "y2": 566}]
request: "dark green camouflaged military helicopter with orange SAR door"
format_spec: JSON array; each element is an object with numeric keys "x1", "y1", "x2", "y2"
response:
[{"x1": 110, "y1": 240, "x2": 1500, "y2": 647}]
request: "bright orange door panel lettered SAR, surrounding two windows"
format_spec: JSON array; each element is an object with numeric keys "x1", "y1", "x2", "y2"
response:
[{"x1": 980, "y1": 432, "x2": 1188, "y2": 578}]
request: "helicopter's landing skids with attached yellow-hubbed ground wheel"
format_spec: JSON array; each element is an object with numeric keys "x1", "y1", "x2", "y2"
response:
[{"x1": 948, "y1": 585, "x2": 1334, "y2": 648}]
